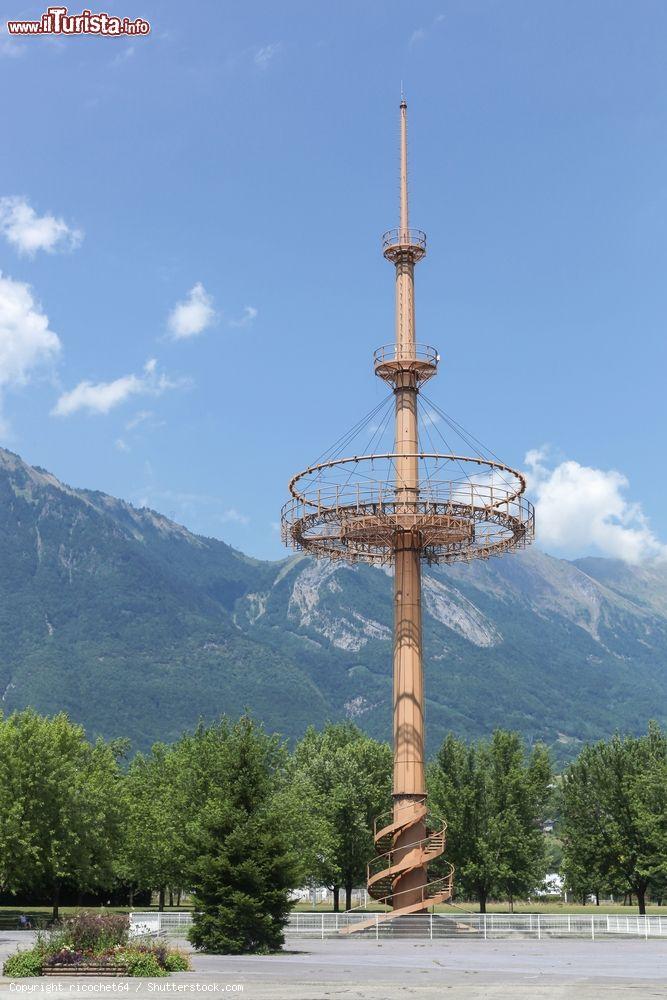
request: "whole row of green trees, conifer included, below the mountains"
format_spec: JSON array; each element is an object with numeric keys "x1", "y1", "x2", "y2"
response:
[{"x1": 0, "y1": 710, "x2": 667, "y2": 951}]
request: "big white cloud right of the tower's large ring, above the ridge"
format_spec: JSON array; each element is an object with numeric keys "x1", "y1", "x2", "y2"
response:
[{"x1": 525, "y1": 448, "x2": 667, "y2": 563}]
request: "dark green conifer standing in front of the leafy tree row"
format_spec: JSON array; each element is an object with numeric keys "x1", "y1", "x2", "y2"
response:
[{"x1": 189, "y1": 716, "x2": 307, "y2": 954}]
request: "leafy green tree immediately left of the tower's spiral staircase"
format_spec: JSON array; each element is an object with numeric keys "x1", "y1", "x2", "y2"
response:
[{"x1": 293, "y1": 722, "x2": 392, "y2": 910}]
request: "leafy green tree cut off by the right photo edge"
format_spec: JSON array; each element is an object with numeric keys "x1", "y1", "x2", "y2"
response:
[{"x1": 562, "y1": 723, "x2": 667, "y2": 913}]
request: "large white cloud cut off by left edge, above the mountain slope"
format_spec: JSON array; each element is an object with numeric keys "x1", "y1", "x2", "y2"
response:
[{"x1": 0, "y1": 272, "x2": 61, "y2": 386}]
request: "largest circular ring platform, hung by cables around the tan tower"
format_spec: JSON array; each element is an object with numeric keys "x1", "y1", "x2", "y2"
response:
[{"x1": 281, "y1": 452, "x2": 534, "y2": 563}]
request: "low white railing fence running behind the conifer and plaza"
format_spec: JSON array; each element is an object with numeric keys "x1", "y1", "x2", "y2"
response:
[{"x1": 130, "y1": 911, "x2": 667, "y2": 941}]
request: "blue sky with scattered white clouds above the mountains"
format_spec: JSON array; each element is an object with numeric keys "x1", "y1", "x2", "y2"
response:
[{"x1": 0, "y1": 0, "x2": 667, "y2": 559}]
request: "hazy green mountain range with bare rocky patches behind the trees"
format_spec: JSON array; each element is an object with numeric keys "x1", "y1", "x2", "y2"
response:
[{"x1": 0, "y1": 449, "x2": 667, "y2": 757}]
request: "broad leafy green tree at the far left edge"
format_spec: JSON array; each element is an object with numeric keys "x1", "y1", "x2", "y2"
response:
[{"x1": 0, "y1": 709, "x2": 122, "y2": 918}]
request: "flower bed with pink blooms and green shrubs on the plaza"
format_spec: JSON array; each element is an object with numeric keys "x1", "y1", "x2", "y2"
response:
[{"x1": 2, "y1": 913, "x2": 190, "y2": 978}]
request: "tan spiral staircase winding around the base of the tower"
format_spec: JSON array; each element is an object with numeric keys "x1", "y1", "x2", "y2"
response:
[{"x1": 341, "y1": 799, "x2": 454, "y2": 934}]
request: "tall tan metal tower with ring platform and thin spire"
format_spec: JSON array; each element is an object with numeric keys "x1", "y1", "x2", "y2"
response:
[{"x1": 282, "y1": 98, "x2": 534, "y2": 928}]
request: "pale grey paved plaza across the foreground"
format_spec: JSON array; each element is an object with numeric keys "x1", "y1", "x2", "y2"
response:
[{"x1": 0, "y1": 932, "x2": 667, "y2": 1000}]
